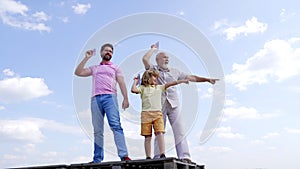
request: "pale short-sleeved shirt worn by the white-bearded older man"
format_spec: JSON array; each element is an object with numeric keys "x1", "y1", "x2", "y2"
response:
[{"x1": 150, "y1": 65, "x2": 187, "y2": 107}]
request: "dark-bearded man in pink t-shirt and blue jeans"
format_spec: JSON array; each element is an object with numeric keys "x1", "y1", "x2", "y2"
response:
[{"x1": 75, "y1": 44, "x2": 131, "y2": 163}]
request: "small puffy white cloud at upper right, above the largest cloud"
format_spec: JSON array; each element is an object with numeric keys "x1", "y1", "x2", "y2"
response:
[{"x1": 214, "y1": 17, "x2": 268, "y2": 40}]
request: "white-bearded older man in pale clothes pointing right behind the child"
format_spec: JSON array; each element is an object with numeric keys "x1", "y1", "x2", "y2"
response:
[{"x1": 143, "y1": 44, "x2": 218, "y2": 162}]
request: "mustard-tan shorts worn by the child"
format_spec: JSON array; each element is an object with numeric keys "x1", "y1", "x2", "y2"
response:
[{"x1": 141, "y1": 111, "x2": 165, "y2": 136}]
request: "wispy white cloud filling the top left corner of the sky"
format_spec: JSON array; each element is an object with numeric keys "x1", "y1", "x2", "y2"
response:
[{"x1": 0, "y1": 0, "x2": 51, "y2": 32}]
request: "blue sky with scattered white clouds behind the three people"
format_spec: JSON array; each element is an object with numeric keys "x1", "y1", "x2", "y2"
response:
[{"x1": 0, "y1": 0, "x2": 300, "y2": 169}]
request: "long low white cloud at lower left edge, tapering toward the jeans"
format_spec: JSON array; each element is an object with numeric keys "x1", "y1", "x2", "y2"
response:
[{"x1": 0, "y1": 118, "x2": 82, "y2": 143}]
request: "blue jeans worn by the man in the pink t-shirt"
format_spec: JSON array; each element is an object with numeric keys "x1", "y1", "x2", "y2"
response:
[{"x1": 91, "y1": 94, "x2": 128, "y2": 162}]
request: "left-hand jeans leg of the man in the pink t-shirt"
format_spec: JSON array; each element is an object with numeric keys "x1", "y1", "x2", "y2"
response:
[{"x1": 91, "y1": 96, "x2": 104, "y2": 163}]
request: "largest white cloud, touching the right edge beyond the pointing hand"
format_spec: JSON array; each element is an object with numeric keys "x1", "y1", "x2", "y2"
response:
[{"x1": 226, "y1": 38, "x2": 300, "y2": 90}]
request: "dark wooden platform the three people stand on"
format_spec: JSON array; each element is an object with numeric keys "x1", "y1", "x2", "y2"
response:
[{"x1": 11, "y1": 157, "x2": 204, "y2": 169}]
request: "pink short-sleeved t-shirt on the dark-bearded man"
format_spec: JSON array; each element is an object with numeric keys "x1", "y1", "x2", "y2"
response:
[{"x1": 89, "y1": 62, "x2": 123, "y2": 96}]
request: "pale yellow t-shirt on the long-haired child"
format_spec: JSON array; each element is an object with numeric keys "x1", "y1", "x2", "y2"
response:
[{"x1": 138, "y1": 85, "x2": 165, "y2": 111}]
